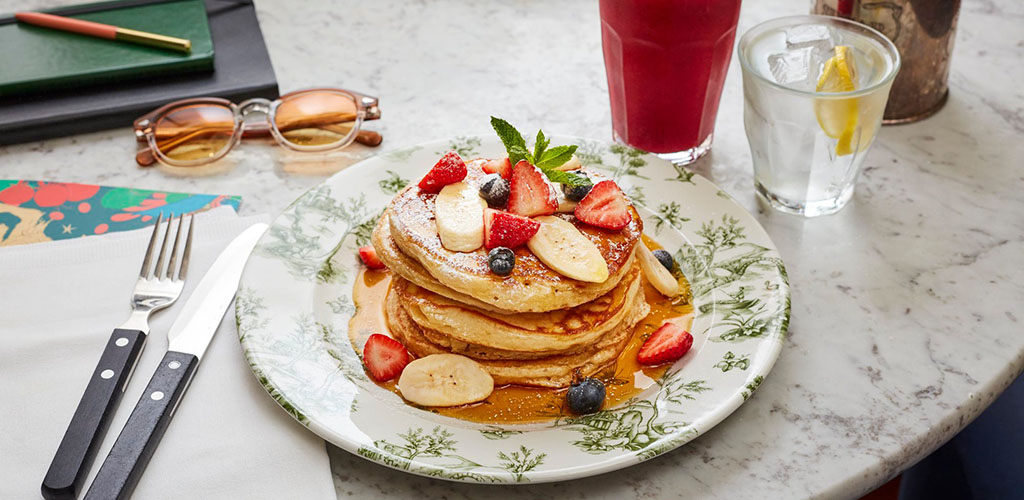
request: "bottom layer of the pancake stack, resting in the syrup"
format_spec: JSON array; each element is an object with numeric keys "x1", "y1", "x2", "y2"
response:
[{"x1": 386, "y1": 286, "x2": 650, "y2": 388}]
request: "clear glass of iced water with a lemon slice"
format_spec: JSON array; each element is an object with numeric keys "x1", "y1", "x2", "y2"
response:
[{"x1": 737, "y1": 15, "x2": 900, "y2": 217}]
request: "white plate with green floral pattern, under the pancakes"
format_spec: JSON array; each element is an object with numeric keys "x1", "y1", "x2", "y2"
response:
[{"x1": 236, "y1": 136, "x2": 790, "y2": 483}]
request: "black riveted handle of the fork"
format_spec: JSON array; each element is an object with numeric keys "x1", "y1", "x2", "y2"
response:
[{"x1": 42, "y1": 328, "x2": 145, "y2": 500}]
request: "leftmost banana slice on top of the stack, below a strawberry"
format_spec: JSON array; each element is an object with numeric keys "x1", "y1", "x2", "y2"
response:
[{"x1": 434, "y1": 182, "x2": 487, "y2": 252}]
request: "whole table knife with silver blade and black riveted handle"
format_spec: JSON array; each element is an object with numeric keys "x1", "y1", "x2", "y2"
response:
[{"x1": 85, "y1": 223, "x2": 266, "y2": 500}]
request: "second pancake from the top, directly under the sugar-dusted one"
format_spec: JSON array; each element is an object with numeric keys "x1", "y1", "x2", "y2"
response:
[{"x1": 391, "y1": 264, "x2": 643, "y2": 357}]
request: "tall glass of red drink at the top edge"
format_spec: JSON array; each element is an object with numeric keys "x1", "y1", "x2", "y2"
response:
[{"x1": 601, "y1": 0, "x2": 740, "y2": 163}]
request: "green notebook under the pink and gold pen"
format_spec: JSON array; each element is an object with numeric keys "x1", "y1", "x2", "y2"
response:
[{"x1": 0, "y1": 0, "x2": 213, "y2": 97}]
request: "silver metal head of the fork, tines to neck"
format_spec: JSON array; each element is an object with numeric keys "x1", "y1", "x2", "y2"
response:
[{"x1": 121, "y1": 214, "x2": 195, "y2": 333}]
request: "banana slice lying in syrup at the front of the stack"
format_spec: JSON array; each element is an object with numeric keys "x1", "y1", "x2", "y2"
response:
[{"x1": 398, "y1": 355, "x2": 495, "y2": 407}]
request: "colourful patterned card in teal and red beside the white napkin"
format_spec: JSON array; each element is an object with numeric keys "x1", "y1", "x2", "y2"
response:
[{"x1": 0, "y1": 180, "x2": 242, "y2": 247}]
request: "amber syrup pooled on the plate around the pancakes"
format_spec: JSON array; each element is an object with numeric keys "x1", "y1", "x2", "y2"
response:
[{"x1": 348, "y1": 236, "x2": 693, "y2": 424}]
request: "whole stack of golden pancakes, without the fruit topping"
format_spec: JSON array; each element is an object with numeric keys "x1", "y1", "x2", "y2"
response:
[{"x1": 373, "y1": 160, "x2": 650, "y2": 387}]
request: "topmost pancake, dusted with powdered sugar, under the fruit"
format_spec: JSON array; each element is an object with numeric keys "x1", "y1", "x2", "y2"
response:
[{"x1": 385, "y1": 160, "x2": 643, "y2": 313}]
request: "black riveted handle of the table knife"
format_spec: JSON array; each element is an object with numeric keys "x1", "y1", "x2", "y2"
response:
[{"x1": 85, "y1": 350, "x2": 199, "y2": 500}]
